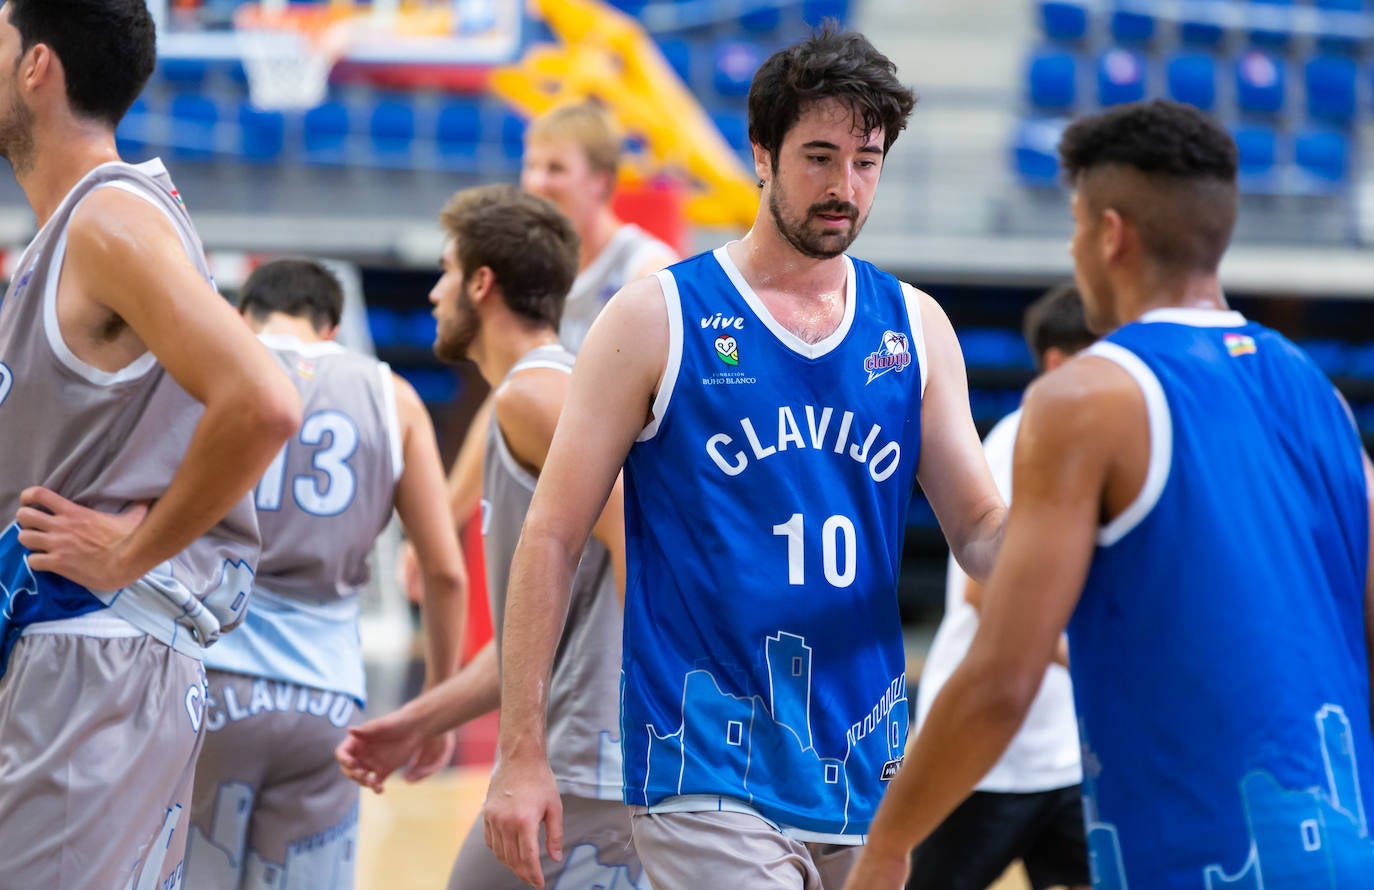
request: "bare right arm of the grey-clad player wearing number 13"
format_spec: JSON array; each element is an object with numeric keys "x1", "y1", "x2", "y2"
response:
[{"x1": 393, "y1": 375, "x2": 467, "y2": 777}]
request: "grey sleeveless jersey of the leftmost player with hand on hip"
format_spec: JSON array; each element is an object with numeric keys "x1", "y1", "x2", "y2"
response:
[{"x1": 0, "y1": 161, "x2": 258, "y2": 672}]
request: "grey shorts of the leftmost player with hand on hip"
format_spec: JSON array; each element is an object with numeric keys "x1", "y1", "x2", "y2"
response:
[{"x1": 0, "y1": 633, "x2": 205, "y2": 890}]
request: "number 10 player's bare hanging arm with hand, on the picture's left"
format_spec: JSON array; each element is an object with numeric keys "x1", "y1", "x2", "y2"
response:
[{"x1": 482, "y1": 279, "x2": 669, "y2": 887}]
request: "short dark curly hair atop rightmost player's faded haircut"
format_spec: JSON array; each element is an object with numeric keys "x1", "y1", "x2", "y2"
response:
[{"x1": 1059, "y1": 99, "x2": 1238, "y2": 181}]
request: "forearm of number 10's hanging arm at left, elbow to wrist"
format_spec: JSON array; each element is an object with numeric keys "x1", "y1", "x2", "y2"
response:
[{"x1": 499, "y1": 522, "x2": 577, "y2": 760}]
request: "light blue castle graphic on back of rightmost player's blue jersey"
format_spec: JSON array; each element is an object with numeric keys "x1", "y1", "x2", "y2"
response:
[{"x1": 1083, "y1": 705, "x2": 1374, "y2": 890}]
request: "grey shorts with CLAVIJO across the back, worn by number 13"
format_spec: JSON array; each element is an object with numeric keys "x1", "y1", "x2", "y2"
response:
[{"x1": 185, "y1": 670, "x2": 359, "y2": 890}]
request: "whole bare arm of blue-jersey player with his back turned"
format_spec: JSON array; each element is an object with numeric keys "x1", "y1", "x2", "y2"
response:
[{"x1": 845, "y1": 357, "x2": 1149, "y2": 890}]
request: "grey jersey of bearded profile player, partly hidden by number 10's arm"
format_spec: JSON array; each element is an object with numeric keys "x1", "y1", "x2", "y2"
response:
[{"x1": 482, "y1": 346, "x2": 622, "y2": 801}]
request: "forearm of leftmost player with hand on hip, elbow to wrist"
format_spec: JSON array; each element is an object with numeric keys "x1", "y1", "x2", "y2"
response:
[{"x1": 117, "y1": 372, "x2": 301, "y2": 575}]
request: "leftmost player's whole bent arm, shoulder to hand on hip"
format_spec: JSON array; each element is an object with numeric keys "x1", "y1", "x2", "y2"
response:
[{"x1": 19, "y1": 188, "x2": 301, "y2": 591}]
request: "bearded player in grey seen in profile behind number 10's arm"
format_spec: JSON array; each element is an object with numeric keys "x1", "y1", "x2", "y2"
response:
[{"x1": 339, "y1": 185, "x2": 647, "y2": 890}]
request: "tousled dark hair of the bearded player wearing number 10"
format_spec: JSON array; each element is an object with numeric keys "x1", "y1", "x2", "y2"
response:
[{"x1": 749, "y1": 21, "x2": 916, "y2": 169}]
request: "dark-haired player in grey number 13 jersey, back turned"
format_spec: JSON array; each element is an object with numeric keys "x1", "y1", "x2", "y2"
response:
[{"x1": 187, "y1": 260, "x2": 467, "y2": 890}]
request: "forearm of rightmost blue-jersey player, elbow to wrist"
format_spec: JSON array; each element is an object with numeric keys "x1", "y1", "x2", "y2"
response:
[{"x1": 868, "y1": 661, "x2": 1035, "y2": 856}]
